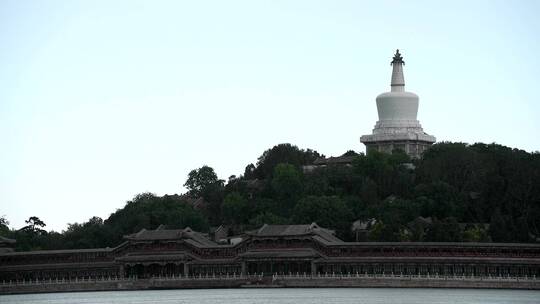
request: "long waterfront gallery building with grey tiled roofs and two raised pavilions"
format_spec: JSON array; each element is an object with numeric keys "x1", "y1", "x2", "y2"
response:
[{"x1": 0, "y1": 223, "x2": 540, "y2": 283}]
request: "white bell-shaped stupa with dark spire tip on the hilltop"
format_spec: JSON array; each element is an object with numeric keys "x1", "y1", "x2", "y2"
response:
[{"x1": 360, "y1": 50, "x2": 435, "y2": 158}]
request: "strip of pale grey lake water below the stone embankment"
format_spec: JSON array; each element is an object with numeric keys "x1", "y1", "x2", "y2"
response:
[{"x1": 0, "y1": 288, "x2": 540, "y2": 304}]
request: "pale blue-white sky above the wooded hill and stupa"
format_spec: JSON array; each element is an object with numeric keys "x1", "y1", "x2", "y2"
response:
[{"x1": 0, "y1": 0, "x2": 540, "y2": 231}]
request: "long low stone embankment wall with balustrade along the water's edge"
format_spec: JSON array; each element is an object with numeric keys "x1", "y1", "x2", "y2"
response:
[{"x1": 0, "y1": 275, "x2": 540, "y2": 294}]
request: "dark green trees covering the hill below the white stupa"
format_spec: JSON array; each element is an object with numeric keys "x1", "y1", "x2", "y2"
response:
[{"x1": 0, "y1": 143, "x2": 540, "y2": 250}]
